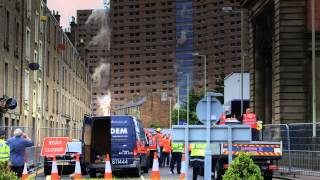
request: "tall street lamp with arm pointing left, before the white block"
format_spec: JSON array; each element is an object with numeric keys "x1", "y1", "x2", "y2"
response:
[{"x1": 222, "y1": 6, "x2": 245, "y2": 115}]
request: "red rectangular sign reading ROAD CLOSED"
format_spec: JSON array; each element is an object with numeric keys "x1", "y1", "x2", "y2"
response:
[{"x1": 41, "y1": 137, "x2": 69, "y2": 157}]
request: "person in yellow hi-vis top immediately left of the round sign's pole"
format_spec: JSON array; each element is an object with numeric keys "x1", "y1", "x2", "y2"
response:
[{"x1": 190, "y1": 143, "x2": 207, "y2": 180}]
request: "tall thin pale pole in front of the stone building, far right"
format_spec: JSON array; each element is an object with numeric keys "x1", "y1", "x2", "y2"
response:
[{"x1": 311, "y1": 0, "x2": 317, "y2": 137}]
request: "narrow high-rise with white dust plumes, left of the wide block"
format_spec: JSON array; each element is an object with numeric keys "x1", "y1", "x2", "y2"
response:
[{"x1": 70, "y1": 9, "x2": 110, "y2": 116}]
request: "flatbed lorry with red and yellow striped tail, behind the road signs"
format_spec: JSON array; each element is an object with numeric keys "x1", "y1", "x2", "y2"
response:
[{"x1": 212, "y1": 141, "x2": 282, "y2": 180}]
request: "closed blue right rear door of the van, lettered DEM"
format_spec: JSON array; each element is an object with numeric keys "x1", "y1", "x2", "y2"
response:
[{"x1": 111, "y1": 116, "x2": 136, "y2": 166}]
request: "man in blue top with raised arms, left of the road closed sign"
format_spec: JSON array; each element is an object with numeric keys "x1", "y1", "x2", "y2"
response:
[{"x1": 7, "y1": 129, "x2": 33, "y2": 177}]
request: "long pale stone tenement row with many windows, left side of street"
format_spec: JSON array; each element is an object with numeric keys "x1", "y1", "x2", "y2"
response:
[{"x1": 0, "y1": 0, "x2": 91, "y2": 142}]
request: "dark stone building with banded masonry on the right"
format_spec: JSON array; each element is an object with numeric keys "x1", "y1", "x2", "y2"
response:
[{"x1": 241, "y1": 0, "x2": 320, "y2": 124}]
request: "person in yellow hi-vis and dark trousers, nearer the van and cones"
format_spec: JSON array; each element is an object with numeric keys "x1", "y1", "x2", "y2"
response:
[{"x1": 170, "y1": 143, "x2": 184, "y2": 174}]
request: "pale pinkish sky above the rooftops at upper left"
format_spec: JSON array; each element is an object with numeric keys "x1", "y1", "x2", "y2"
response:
[{"x1": 47, "y1": 0, "x2": 103, "y2": 28}]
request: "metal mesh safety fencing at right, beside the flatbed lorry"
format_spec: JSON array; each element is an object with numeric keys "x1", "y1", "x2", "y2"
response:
[{"x1": 262, "y1": 123, "x2": 320, "y2": 176}]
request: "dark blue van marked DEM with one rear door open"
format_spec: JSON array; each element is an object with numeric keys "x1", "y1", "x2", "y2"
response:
[{"x1": 82, "y1": 115, "x2": 149, "y2": 178}]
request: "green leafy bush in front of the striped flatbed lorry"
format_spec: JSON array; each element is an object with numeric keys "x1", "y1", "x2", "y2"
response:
[{"x1": 223, "y1": 152, "x2": 263, "y2": 180}]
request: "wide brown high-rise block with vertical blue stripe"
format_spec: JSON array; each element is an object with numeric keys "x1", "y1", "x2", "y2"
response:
[{"x1": 110, "y1": 0, "x2": 248, "y2": 124}]
